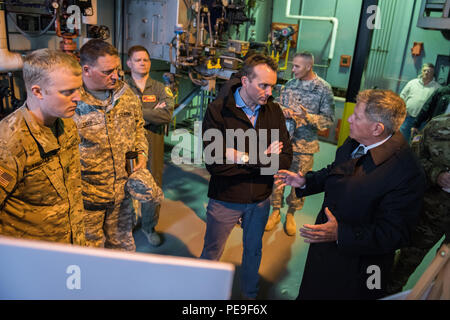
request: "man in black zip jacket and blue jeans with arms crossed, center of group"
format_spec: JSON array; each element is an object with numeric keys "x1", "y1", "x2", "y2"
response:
[{"x1": 201, "y1": 54, "x2": 292, "y2": 299}]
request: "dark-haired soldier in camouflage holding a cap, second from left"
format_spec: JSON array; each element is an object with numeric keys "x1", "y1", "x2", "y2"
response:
[{"x1": 74, "y1": 39, "x2": 148, "y2": 251}]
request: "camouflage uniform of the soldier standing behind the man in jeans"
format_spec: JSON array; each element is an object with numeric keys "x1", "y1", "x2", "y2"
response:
[{"x1": 271, "y1": 76, "x2": 334, "y2": 210}]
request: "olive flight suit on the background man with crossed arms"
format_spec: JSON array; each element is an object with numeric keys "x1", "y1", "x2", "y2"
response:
[{"x1": 125, "y1": 75, "x2": 174, "y2": 233}]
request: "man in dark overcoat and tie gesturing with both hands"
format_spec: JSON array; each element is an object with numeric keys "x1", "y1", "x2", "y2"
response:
[{"x1": 275, "y1": 90, "x2": 425, "y2": 299}]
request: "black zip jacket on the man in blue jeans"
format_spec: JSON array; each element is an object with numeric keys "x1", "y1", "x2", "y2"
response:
[{"x1": 202, "y1": 79, "x2": 292, "y2": 203}]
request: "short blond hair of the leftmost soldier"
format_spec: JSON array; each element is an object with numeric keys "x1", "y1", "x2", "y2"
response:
[{"x1": 23, "y1": 49, "x2": 81, "y2": 92}]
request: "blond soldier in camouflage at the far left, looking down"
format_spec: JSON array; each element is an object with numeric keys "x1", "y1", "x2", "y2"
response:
[{"x1": 0, "y1": 49, "x2": 85, "y2": 245}]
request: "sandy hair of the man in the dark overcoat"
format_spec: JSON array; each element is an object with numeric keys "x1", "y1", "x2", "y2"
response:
[{"x1": 356, "y1": 89, "x2": 406, "y2": 134}]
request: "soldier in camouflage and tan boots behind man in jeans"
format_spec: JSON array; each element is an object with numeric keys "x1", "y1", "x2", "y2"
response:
[{"x1": 265, "y1": 52, "x2": 334, "y2": 236}]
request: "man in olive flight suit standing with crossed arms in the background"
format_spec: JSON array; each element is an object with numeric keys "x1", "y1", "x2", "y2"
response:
[{"x1": 125, "y1": 46, "x2": 174, "y2": 246}]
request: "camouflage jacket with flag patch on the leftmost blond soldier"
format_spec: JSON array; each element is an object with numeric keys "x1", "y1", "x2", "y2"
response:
[{"x1": 0, "y1": 105, "x2": 85, "y2": 245}]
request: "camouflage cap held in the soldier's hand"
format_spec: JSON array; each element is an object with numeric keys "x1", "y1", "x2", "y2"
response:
[{"x1": 126, "y1": 169, "x2": 164, "y2": 204}]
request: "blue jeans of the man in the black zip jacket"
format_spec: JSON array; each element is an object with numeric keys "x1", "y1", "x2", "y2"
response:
[{"x1": 200, "y1": 198, "x2": 270, "y2": 298}]
